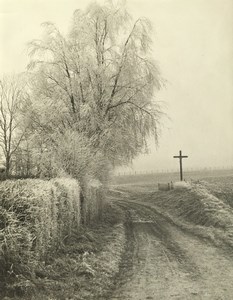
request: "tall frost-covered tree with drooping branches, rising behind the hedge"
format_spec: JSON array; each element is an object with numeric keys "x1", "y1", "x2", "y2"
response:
[{"x1": 28, "y1": 2, "x2": 162, "y2": 171}]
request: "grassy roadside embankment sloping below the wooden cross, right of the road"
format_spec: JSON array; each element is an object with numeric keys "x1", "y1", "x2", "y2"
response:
[{"x1": 145, "y1": 182, "x2": 233, "y2": 247}]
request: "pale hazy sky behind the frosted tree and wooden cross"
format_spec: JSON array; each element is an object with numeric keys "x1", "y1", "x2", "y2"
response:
[{"x1": 0, "y1": 0, "x2": 233, "y2": 170}]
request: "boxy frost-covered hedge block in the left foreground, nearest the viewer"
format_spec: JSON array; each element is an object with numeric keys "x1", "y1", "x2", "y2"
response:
[{"x1": 0, "y1": 179, "x2": 81, "y2": 281}]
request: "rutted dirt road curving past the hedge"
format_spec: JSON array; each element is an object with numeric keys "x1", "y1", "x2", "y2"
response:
[{"x1": 107, "y1": 199, "x2": 233, "y2": 300}]
